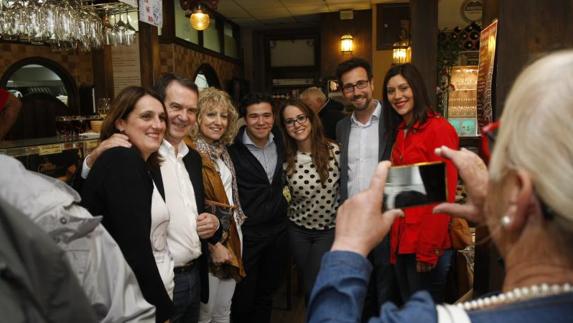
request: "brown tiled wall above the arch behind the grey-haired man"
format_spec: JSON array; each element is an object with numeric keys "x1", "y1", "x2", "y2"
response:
[{"x1": 159, "y1": 44, "x2": 241, "y2": 89}]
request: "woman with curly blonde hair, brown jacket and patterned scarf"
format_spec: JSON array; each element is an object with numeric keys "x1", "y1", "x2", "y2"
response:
[{"x1": 192, "y1": 88, "x2": 245, "y2": 322}]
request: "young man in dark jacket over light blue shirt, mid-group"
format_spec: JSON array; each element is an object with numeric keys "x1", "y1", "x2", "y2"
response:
[{"x1": 229, "y1": 93, "x2": 288, "y2": 323}]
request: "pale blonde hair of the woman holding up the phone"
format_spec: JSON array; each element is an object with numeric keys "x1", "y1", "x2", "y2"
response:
[{"x1": 490, "y1": 50, "x2": 573, "y2": 235}]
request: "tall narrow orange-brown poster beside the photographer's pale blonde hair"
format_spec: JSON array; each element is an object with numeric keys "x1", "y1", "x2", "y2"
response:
[{"x1": 477, "y1": 20, "x2": 497, "y2": 132}]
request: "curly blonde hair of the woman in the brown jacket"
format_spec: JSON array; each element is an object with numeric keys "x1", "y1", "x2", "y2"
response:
[{"x1": 191, "y1": 87, "x2": 238, "y2": 145}]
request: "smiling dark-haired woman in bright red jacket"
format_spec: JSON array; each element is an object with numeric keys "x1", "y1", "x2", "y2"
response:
[{"x1": 383, "y1": 64, "x2": 459, "y2": 302}]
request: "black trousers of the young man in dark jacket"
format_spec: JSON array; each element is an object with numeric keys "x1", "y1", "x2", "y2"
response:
[{"x1": 231, "y1": 228, "x2": 289, "y2": 323}]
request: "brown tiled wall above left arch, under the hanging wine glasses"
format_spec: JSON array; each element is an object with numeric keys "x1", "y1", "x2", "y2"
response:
[{"x1": 0, "y1": 43, "x2": 93, "y2": 86}]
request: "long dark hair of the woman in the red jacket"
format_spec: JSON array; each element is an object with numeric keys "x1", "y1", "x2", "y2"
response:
[{"x1": 382, "y1": 63, "x2": 434, "y2": 134}]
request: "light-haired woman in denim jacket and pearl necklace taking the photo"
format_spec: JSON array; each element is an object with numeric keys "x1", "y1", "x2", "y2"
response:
[{"x1": 309, "y1": 51, "x2": 573, "y2": 323}]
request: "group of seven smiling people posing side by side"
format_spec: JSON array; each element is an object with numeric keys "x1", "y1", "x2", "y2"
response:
[{"x1": 32, "y1": 58, "x2": 458, "y2": 323}]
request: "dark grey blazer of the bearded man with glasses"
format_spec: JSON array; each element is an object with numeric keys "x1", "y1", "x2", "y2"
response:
[{"x1": 336, "y1": 102, "x2": 395, "y2": 204}]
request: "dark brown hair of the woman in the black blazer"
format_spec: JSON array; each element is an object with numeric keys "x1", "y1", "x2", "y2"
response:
[{"x1": 100, "y1": 86, "x2": 165, "y2": 166}]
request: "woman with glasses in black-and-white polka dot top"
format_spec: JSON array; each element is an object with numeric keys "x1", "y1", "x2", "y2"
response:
[{"x1": 279, "y1": 100, "x2": 340, "y2": 299}]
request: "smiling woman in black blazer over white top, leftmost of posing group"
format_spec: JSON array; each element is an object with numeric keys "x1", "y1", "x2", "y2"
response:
[{"x1": 82, "y1": 87, "x2": 173, "y2": 322}]
